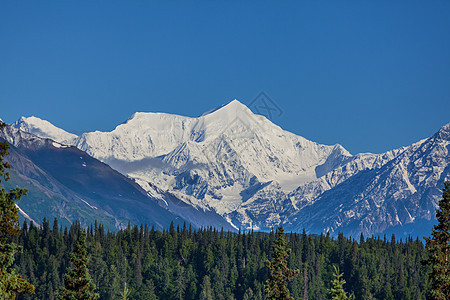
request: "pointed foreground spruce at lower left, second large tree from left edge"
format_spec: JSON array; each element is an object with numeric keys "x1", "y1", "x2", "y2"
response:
[{"x1": 59, "y1": 229, "x2": 99, "y2": 300}]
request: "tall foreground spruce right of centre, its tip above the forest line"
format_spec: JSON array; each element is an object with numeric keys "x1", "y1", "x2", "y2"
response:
[{"x1": 264, "y1": 226, "x2": 298, "y2": 300}]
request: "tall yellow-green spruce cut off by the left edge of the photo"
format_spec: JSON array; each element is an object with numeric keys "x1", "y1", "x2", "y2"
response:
[{"x1": 0, "y1": 121, "x2": 34, "y2": 299}]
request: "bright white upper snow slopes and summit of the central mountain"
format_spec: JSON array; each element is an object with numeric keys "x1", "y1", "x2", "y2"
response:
[{"x1": 74, "y1": 100, "x2": 320, "y2": 161}]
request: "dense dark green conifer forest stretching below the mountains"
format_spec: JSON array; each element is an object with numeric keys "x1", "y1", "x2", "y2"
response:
[{"x1": 13, "y1": 219, "x2": 431, "y2": 300}]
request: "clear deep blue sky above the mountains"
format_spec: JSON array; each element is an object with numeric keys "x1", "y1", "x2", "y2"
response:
[{"x1": 0, "y1": 1, "x2": 450, "y2": 153}]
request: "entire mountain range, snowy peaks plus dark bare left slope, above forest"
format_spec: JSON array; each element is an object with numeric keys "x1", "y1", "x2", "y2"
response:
[{"x1": 7, "y1": 100, "x2": 450, "y2": 236}]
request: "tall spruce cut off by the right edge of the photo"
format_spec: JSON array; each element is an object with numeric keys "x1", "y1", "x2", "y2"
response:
[{"x1": 424, "y1": 182, "x2": 450, "y2": 300}]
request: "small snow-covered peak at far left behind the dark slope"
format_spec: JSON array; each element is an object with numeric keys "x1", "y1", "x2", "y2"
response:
[{"x1": 12, "y1": 116, "x2": 78, "y2": 144}]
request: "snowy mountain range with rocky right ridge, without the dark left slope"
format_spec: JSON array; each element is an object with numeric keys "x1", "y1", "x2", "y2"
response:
[{"x1": 15, "y1": 100, "x2": 449, "y2": 234}]
